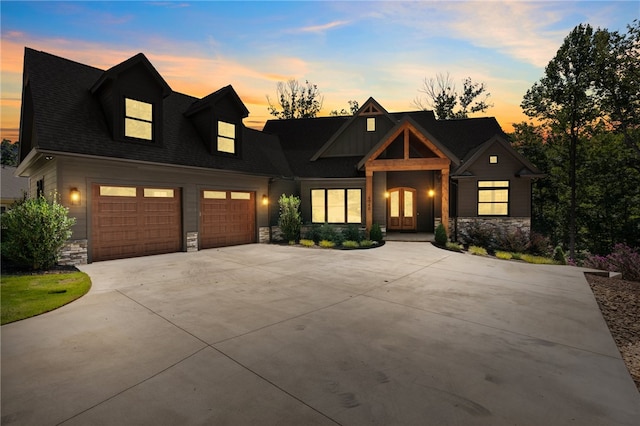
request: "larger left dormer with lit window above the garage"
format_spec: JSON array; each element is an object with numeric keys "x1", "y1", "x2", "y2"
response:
[{"x1": 91, "y1": 53, "x2": 171, "y2": 145}]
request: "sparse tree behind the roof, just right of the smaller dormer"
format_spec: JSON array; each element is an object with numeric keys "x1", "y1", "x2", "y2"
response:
[{"x1": 267, "y1": 79, "x2": 323, "y2": 120}]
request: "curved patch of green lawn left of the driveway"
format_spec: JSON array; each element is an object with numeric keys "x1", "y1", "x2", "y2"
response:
[{"x1": 0, "y1": 272, "x2": 91, "y2": 324}]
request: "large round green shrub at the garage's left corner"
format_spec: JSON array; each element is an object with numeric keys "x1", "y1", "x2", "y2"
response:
[{"x1": 2, "y1": 196, "x2": 76, "y2": 270}]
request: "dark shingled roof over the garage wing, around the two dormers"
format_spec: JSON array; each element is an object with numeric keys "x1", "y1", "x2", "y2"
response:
[{"x1": 25, "y1": 48, "x2": 289, "y2": 176}]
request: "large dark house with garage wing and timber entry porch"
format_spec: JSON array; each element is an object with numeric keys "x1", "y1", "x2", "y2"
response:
[{"x1": 17, "y1": 48, "x2": 540, "y2": 263}]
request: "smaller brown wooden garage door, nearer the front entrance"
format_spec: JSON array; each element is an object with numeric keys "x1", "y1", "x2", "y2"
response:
[{"x1": 200, "y1": 190, "x2": 256, "y2": 249}]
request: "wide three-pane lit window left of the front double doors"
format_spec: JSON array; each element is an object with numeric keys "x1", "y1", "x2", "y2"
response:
[{"x1": 311, "y1": 188, "x2": 362, "y2": 223}]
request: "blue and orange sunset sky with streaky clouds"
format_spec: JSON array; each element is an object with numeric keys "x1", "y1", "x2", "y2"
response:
[{"x1": 0, "y1": 0, "x2": 640, "y2": 141}]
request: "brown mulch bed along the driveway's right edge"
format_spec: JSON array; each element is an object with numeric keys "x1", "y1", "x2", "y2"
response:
[{"x1": 586, "y1": 274, "x2": 640, "y2": 391}]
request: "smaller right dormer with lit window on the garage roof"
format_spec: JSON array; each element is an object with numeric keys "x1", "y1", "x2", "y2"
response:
[{"x1": 184, "y1": 85, "x2": 249, "y2": 156}]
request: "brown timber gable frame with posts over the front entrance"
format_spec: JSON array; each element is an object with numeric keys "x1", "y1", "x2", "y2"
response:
[{"x1": 361, "y1": 120, "x2": 455, "y2": 234}]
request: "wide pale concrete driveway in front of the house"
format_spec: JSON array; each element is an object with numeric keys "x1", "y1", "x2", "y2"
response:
[{"x1": 1, "y1": 242, "x2": 640, "y2": 426}]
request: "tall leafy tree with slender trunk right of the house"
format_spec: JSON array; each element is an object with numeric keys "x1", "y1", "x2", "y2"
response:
[{"x1": 521, "y1": 24, "x2": 598, "y2": 258}]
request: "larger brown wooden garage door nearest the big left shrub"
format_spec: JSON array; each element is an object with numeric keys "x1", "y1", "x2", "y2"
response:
[{"x1": 91, "y1": 184, "x2": 182, "y2": 261}]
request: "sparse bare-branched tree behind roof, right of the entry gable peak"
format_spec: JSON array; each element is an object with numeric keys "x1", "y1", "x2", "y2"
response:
[{"x1": 413, "y1": 73, "x2": 493, "y2": 120}]
